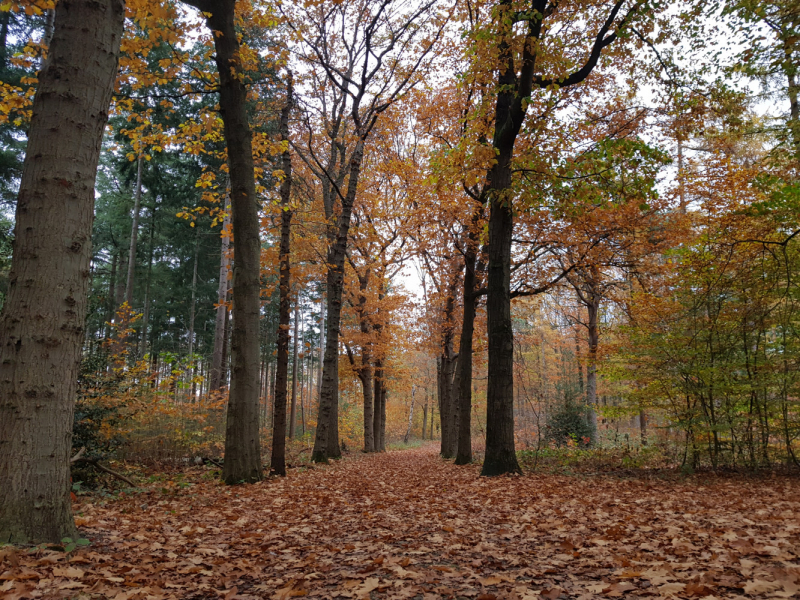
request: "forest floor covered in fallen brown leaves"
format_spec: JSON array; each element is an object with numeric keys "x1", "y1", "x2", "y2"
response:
[{"x1": 0, "y1": 444, "x2": 800, "y2": 600}]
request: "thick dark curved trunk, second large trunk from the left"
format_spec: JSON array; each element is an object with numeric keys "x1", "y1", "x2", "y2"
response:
[{"x1": 189, "y1": 0, "x2": 261, "y2": 485}]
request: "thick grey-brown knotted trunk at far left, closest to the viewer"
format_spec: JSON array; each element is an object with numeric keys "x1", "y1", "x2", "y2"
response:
[{"x1": 0, "y1": 0, "x2": 125, "y2": 544}]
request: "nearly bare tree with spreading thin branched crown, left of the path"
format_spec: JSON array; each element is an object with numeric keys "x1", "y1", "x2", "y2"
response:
[{"x1": 293, "y1": 0, "x2": 446, "y2": 462}]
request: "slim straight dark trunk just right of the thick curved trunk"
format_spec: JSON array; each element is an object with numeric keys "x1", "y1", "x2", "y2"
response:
[{"x1": 270, "y1": 80, "x2": 293, "y2": 476}]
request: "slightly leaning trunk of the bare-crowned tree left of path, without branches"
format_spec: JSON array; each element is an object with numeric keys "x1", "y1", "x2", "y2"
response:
[{"x1": 311, "y1": 140, "x2": 364, "y2": 462}]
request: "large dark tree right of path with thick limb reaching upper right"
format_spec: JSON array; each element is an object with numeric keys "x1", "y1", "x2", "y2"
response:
[{"x1": 481, "y1": 0, "x2": 638, "y2": 476}]
